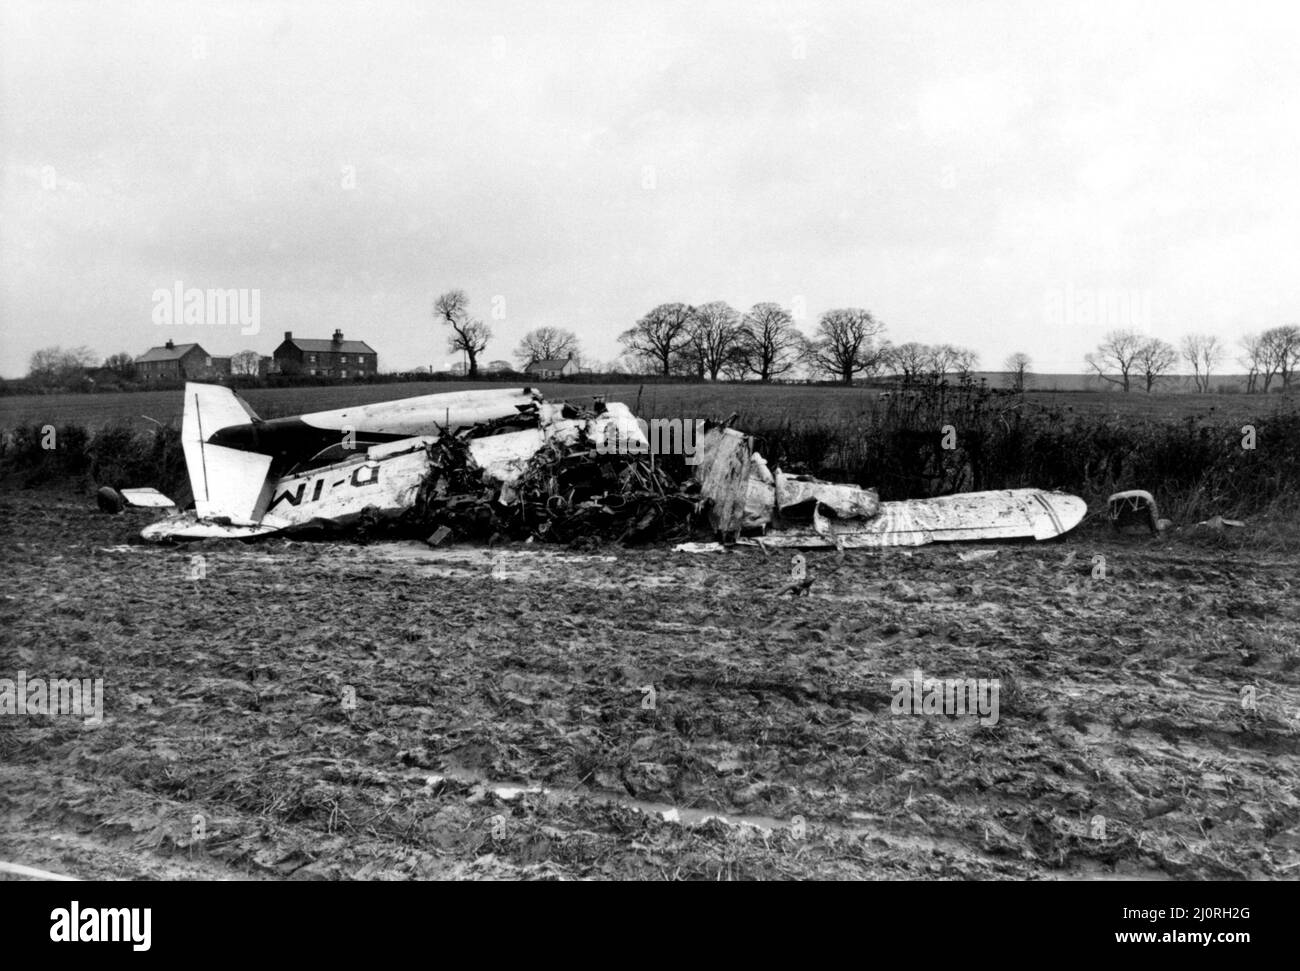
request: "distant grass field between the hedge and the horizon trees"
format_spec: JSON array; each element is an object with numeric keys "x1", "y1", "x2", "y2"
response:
[{"x1": 0, "y1": 381, "x2": 1300, "y2": 429}]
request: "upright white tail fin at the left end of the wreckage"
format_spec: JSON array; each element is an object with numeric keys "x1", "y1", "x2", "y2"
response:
[{"x1": 181, "y1": 382, "x2": 272, "y2": 525}]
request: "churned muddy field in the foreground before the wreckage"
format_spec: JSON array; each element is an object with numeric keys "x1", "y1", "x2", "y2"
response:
[{"x1": 0, "y1": 494, "x2": 1300, "y2": 880}]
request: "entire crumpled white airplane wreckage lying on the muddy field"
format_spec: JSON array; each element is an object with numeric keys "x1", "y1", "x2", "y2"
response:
[{"x1": 129, "y1": 382, "x2": 1087, "y2": 549}]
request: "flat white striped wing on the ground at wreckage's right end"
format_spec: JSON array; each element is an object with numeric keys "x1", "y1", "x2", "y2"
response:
[{"x1": 743, "y1": 489, "x2": 1088, "y2": 550}]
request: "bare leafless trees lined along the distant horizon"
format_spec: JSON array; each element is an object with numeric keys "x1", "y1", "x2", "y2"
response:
[{"x1": 15, "y1": 290, "x2": 1300, "y2": 393}]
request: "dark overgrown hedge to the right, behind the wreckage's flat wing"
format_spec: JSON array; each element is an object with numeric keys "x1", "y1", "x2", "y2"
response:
[{"x1": 741, "y1": 383, "x2": 1300, "y2": 519}]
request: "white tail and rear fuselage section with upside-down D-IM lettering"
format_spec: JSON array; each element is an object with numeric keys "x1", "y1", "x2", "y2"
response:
[{"x1": 142, "y1": 382, "x2": 640, "y2": 541}]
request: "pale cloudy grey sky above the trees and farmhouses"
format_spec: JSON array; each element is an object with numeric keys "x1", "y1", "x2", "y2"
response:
[{"x1": 0, "y1": 0, "x2": 1300, "y2": 376}]
